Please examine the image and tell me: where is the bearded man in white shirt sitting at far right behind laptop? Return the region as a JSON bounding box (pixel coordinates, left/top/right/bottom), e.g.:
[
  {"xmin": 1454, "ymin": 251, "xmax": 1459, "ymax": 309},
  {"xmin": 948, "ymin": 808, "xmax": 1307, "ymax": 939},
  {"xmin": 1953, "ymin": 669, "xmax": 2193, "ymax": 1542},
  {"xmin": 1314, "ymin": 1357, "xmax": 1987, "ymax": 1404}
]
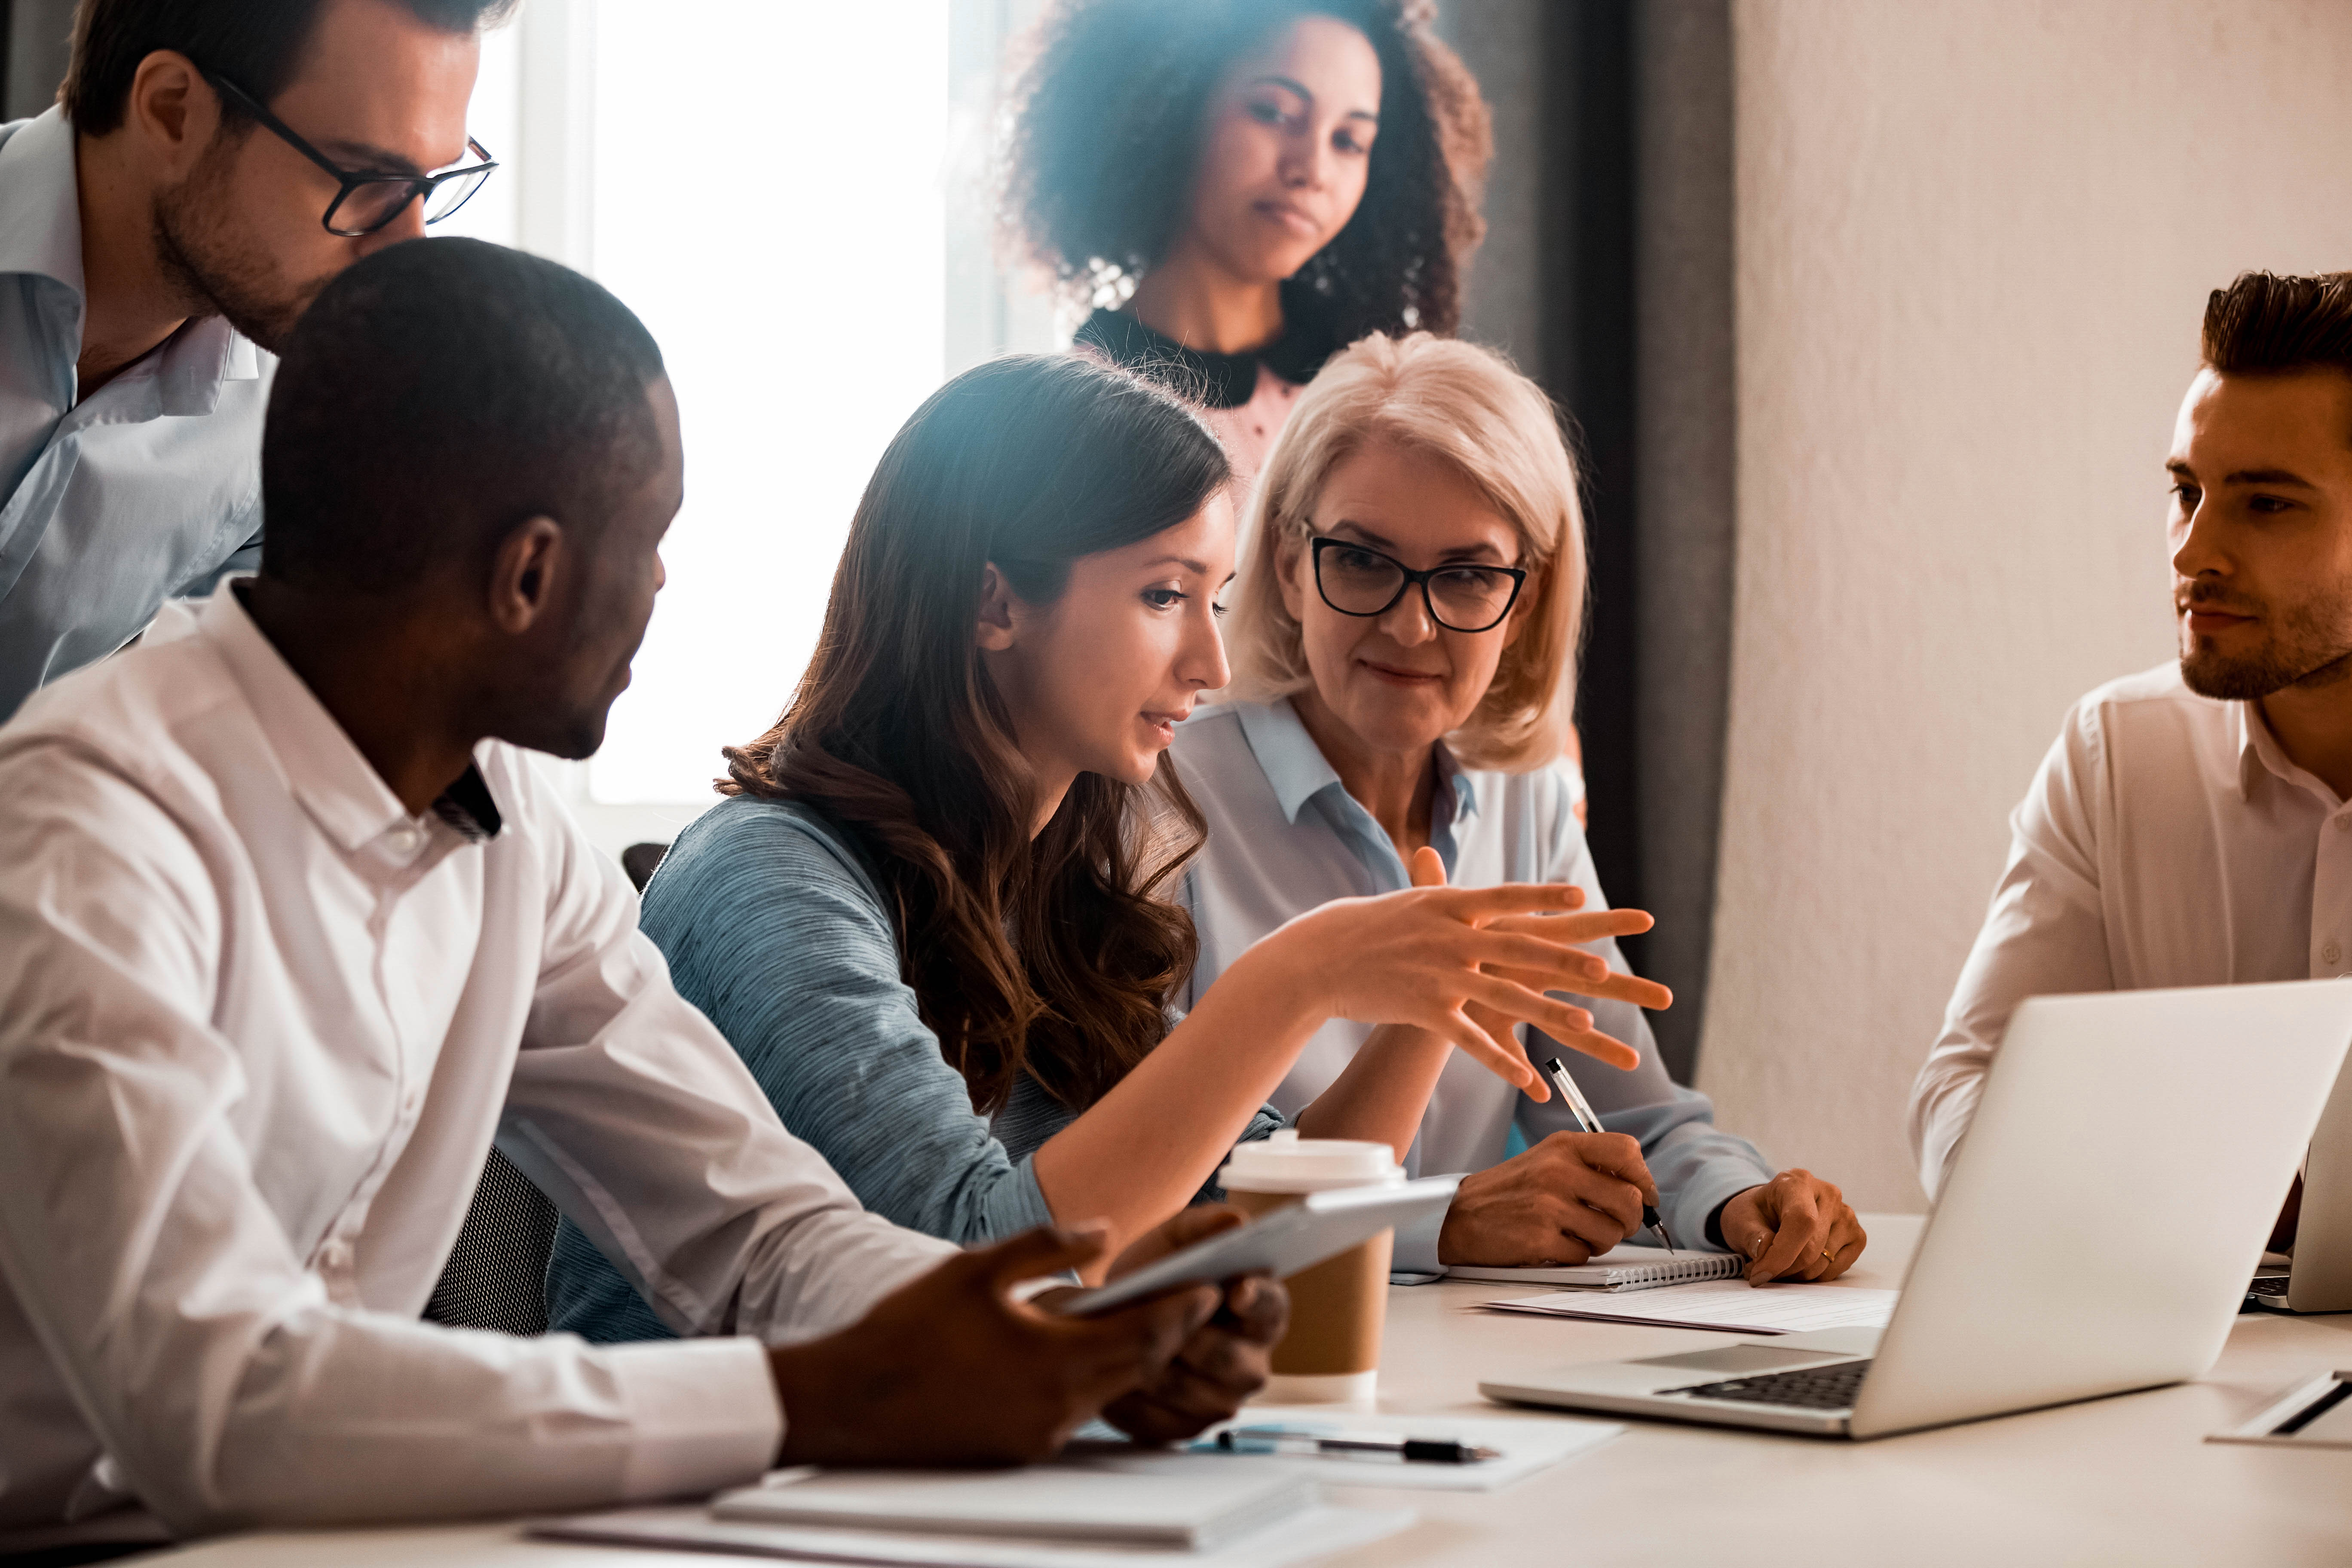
[{"xmin": 1910, "ymin": 273, "xmax": 2352, "ymax": 1246}]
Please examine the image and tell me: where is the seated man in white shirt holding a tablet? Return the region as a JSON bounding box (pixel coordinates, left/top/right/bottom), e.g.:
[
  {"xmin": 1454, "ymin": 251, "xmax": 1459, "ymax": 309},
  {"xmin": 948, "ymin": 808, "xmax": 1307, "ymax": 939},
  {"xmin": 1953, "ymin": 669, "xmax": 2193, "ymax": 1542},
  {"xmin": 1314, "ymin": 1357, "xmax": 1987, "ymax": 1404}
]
[{"xmin": 0, "ymin": 240, "xmax": 1284, "ymax": 1544}]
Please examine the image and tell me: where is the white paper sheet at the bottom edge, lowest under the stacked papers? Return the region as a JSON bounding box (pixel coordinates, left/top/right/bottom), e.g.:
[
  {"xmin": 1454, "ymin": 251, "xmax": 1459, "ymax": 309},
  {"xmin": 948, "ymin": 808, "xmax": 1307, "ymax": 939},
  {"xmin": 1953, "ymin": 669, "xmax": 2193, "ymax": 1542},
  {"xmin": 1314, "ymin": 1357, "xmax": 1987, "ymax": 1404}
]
[{"xmin": 529, "ymin": 1504, "xmax": 1414, "ymax": 1568}]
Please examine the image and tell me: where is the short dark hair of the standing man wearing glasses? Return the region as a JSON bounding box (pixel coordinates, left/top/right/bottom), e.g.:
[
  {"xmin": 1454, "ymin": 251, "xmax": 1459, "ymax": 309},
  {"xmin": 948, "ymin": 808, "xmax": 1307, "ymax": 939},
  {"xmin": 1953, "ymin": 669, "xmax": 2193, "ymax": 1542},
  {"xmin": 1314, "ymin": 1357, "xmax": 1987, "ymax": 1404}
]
[{"xmin": 56, "ymin": 0, "xmax": 518, "ymax": 136}]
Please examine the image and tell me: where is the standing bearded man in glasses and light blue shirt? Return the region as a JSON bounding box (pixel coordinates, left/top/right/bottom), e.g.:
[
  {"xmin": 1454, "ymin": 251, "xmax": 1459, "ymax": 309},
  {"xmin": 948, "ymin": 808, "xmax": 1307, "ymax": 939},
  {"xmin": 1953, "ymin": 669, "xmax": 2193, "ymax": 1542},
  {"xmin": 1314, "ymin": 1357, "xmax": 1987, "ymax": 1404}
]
[{"xmin": 0, "ymin": 0, "xmax": 513, "ymax": 720}]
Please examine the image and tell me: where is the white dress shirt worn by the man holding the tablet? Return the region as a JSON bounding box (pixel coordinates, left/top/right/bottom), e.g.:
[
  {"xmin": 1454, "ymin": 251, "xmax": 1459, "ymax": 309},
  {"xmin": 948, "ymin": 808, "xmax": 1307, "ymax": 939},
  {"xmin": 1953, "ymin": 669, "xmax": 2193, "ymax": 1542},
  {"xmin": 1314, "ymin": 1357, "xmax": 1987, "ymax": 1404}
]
[{"xmin": 0, "ymin": 585, "xmax": 952, "ymax": 1530}]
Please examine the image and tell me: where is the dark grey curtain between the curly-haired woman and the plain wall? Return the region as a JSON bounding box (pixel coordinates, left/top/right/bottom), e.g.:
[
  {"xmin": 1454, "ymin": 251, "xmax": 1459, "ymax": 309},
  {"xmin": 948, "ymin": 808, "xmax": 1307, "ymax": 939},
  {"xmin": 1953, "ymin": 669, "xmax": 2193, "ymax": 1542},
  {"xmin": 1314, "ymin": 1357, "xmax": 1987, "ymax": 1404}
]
[{"xmin": 1442, "ymin": 0, "xmax": 1736, "ymax": 1081}]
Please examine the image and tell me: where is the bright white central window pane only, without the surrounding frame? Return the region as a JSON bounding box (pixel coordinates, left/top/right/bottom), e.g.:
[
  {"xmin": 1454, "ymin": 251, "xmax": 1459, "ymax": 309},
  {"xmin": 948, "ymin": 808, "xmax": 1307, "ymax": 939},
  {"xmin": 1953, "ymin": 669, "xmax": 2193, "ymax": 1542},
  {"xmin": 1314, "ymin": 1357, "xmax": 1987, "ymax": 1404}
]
[{"xmin": 588, "ymin": 0, "xmax": 948, "ymax": 802}]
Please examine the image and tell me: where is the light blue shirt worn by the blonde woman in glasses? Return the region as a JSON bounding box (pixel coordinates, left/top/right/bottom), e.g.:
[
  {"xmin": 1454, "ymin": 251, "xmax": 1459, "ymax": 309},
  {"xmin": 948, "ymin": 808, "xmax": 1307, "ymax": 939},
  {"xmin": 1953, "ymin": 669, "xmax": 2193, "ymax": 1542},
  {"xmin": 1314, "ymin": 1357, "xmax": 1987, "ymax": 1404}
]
[{"xmin": 1169, "ymin": 701, "xmax": 1771, "ymax": 1272}]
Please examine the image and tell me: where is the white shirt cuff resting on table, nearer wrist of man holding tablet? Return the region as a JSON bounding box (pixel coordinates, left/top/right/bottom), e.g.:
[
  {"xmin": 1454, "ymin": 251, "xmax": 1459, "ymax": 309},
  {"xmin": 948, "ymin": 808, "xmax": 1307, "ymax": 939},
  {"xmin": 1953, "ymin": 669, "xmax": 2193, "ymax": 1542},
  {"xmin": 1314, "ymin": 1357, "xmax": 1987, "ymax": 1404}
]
[{"xmin": 616, "ymin": 1338, "xmax": 783, "ymax": 1502}]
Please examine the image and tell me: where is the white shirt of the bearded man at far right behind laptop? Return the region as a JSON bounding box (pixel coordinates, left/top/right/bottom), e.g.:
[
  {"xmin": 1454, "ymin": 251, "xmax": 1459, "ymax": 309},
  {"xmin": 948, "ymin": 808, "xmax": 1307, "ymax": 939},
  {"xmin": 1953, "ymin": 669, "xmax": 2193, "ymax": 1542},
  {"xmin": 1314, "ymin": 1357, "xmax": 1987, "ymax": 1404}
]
[{"xmin": 1910, "ymin": 665, "xmax": 2352, "ymax": 1197}]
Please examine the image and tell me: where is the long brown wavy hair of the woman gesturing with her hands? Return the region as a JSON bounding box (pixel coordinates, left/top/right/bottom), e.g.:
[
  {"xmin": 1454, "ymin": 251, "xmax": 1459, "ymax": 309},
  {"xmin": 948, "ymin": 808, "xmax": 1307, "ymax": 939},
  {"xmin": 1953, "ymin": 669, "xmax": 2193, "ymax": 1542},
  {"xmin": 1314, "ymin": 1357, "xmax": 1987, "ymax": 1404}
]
[{"xmin": 720, "ymin": 355, "xmax": 1230, "ymax": 1112}]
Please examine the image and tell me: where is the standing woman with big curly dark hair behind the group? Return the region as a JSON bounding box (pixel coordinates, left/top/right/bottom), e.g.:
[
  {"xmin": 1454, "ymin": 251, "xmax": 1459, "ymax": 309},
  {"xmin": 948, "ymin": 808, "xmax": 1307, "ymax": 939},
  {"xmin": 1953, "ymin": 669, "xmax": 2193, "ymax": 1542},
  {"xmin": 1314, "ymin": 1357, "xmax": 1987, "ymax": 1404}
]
[{"xmin": 1004, "ymin": 0, "xmax": 1489, "ymax": 498}]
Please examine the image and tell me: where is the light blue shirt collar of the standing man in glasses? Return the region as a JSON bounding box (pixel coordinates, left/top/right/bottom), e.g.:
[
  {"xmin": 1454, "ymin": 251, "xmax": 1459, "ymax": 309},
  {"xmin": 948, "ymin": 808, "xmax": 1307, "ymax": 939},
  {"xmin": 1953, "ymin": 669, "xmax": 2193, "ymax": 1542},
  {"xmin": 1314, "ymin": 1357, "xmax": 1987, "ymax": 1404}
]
[{"xmin": 0, "ymin": 106, "xmax": 261, "ymax": 419}]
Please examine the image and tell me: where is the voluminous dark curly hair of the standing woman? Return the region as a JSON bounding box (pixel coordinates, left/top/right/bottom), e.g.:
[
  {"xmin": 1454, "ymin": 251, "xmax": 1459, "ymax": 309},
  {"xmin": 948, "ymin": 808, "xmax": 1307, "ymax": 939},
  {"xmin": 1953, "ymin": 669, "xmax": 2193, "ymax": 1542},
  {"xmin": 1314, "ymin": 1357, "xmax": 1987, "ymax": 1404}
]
[{"xmin": 1002, "ymin": 0, "xmax": 1494, "ymax": 343}]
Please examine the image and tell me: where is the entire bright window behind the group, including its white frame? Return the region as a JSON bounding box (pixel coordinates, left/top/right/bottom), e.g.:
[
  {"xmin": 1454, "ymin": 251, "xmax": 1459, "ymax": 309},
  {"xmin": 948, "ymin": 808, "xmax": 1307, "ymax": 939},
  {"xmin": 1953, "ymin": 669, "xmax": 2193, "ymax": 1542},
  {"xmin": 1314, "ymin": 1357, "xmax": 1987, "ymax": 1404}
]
[{"xmin": 435, "ymin": 0, "xmax": 1054, "ymax": 846}]
